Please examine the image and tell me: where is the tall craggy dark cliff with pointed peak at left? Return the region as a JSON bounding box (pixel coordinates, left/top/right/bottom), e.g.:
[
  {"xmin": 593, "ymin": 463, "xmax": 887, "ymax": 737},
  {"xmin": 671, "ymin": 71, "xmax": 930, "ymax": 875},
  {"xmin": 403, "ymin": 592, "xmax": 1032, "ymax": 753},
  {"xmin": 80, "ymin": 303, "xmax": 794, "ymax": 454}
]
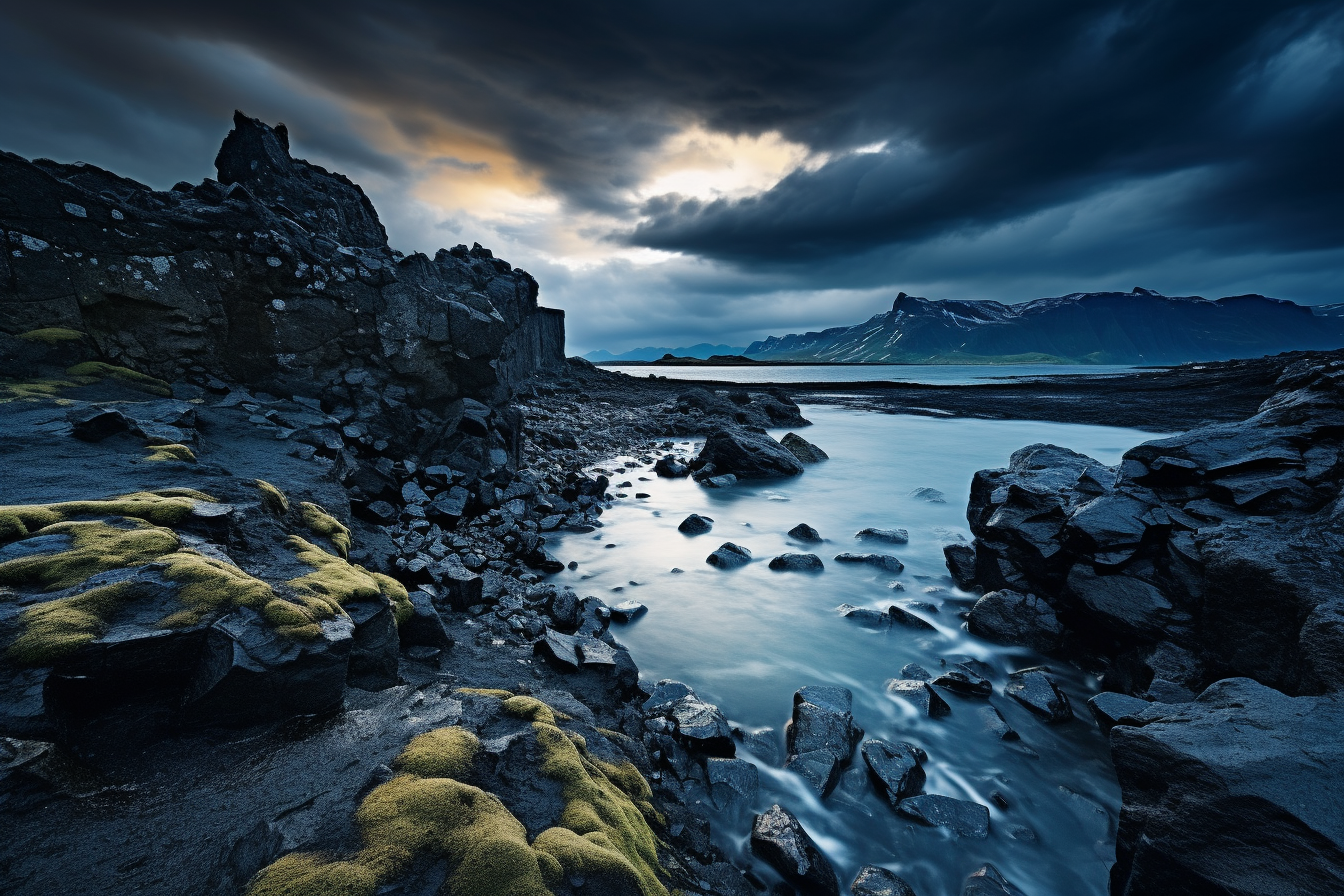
[{"xmin": 0, "ymin": 113, "xmax": 564, "ymax": 459}]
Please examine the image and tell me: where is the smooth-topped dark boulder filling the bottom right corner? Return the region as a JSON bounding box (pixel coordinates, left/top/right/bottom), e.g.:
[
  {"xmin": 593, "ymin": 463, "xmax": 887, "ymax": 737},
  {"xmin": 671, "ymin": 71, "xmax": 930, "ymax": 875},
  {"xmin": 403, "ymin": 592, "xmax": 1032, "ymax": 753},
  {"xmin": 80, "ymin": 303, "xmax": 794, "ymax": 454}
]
[{"xmin": 1110, "ymin": 678, "xmax": 1344, "ymax": 896}]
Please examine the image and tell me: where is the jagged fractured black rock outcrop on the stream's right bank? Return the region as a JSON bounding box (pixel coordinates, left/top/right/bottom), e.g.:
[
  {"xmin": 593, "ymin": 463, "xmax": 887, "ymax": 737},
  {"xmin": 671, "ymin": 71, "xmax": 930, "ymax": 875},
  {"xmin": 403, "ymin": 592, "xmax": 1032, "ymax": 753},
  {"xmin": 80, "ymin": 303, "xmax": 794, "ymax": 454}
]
[{"xmin": 966, "ymin": 355, "xmax": 1344, "ymax": 700}]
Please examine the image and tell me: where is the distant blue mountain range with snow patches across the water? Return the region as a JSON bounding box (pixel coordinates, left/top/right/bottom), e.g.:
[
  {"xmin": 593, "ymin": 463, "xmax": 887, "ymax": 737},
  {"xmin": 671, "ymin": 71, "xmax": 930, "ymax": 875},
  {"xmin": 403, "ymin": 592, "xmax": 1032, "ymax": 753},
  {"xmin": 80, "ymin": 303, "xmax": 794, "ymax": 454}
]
[{"xmin": 743, "ymin": 287, "xmax": 1344, "ymax": 364}]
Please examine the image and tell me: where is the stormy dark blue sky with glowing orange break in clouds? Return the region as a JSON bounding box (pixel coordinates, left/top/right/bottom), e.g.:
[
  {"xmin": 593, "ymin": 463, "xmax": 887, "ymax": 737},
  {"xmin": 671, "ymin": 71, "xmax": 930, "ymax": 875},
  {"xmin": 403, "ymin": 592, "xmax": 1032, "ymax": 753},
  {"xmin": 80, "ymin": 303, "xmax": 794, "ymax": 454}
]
[{"xmin": 0, "ymin": 0, "xmax": 1344, "ymax": 353}]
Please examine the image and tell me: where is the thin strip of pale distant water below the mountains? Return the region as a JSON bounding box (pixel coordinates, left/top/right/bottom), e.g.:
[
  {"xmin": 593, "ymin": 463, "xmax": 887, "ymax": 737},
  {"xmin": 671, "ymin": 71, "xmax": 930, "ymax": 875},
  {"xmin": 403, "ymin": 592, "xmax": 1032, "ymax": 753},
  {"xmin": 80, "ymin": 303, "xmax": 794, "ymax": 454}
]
[{"xmin": 603, "ymin": 364, "xmax": 1138, "ymax": 386}]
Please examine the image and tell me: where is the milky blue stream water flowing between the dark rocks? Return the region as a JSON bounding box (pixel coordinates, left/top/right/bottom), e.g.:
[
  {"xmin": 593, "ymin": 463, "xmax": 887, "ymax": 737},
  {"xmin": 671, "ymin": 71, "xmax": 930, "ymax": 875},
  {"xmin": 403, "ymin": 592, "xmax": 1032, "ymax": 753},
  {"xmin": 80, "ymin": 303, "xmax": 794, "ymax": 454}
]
[{"xmin": 548, "ymin": 406, "xmax": 1157, "ymax": 896}]
